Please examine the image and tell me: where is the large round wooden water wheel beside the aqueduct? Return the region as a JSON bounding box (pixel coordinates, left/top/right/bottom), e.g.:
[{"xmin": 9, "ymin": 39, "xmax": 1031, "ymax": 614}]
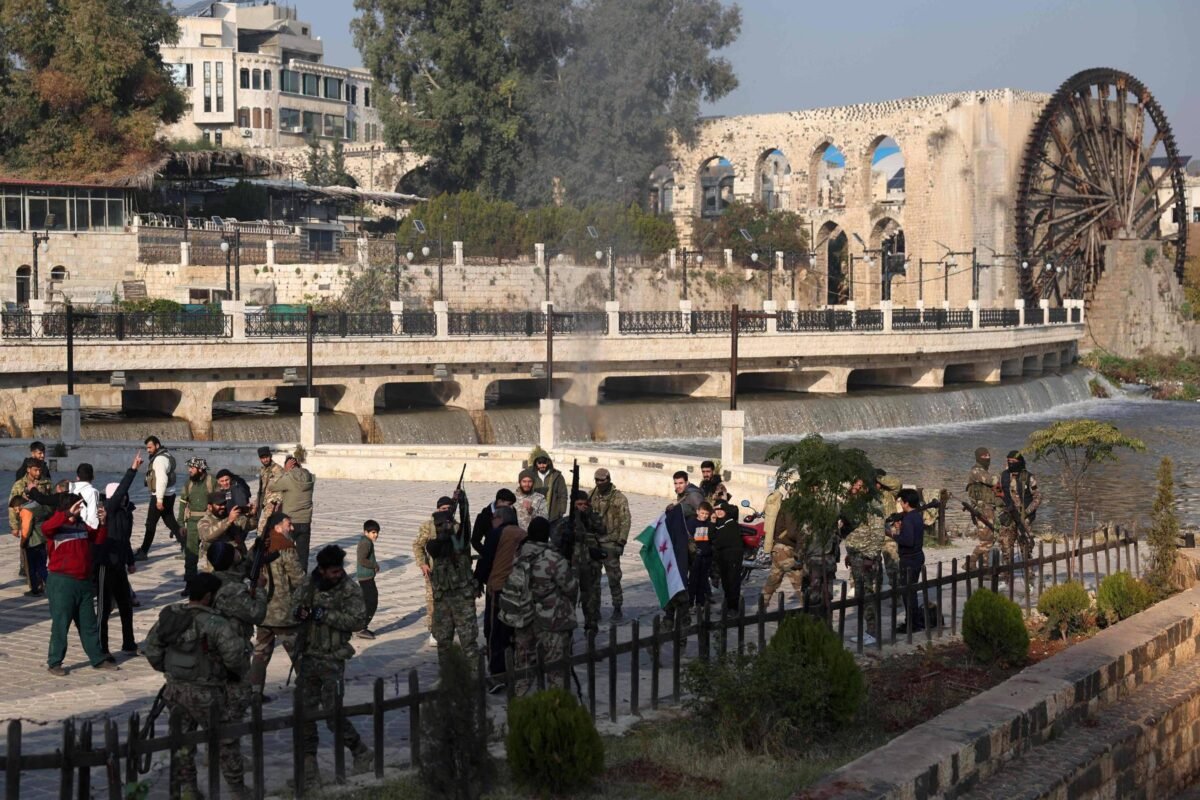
[{"xmin": 1016, "ymin": 68, "xmax": 1187, "ymax": 302}]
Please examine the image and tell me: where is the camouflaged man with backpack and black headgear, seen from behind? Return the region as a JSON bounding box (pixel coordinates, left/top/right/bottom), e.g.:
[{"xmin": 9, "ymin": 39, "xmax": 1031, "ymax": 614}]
[{"xmin": 509, "ymin": 517, "xmax": 580, "ymax": 693}]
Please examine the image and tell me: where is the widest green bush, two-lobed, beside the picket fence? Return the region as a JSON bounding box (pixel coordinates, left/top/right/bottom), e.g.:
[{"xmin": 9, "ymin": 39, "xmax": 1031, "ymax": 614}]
[{"xmin": 684, "ymin": 614, "xmax": 866, "ymax": 753}]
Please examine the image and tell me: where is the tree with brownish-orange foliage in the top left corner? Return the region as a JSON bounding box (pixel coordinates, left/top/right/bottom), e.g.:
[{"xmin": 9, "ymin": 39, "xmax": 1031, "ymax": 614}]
[{"xmin": 0, "ymin": 0, "xmax": 184, "ymax": 179}]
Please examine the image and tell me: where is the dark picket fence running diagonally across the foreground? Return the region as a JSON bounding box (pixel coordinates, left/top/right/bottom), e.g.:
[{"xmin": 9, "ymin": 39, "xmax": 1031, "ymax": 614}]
[{"xmin": 0, "ymin": 527, "xmax": 1140, "ymax": 800}]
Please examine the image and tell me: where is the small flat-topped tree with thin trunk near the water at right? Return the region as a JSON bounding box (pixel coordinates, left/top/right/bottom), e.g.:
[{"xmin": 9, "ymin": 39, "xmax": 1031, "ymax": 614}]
[{"xmin": 1026, "ymin": 420, "xmax": 1146, "ymax": 579}]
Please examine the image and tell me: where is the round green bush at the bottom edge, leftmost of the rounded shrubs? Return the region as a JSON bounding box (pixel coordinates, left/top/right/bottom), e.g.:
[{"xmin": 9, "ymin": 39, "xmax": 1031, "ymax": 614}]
[{"xmin": 504, "ymin": 688, "xmax": 604, "ymax": 795}]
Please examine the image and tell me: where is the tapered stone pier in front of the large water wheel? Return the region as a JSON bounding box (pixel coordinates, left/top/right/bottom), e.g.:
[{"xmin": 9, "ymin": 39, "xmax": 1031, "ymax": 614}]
[{"xmin": 1080, "ymin": 240, "xmax": 1200, "ymax": 357}]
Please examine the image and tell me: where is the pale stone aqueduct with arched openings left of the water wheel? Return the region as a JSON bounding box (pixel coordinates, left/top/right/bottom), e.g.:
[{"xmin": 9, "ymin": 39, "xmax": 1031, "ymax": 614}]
[{"xmin": 655, "ymin": 89, "xmax": 1050, "ymax": 307}]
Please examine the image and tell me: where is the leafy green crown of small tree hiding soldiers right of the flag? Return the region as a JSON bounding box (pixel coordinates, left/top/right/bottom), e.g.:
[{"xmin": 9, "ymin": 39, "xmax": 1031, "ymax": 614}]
[{"xmin": 767, "ymin": 434, "xmax": 878, "ymax": 556}]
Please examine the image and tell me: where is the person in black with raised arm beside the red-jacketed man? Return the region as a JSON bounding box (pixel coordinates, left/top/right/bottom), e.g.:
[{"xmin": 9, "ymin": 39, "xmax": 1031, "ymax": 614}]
[{"xmin": 95, "ymin": 452, "xmax": 142, "ymax": 655}]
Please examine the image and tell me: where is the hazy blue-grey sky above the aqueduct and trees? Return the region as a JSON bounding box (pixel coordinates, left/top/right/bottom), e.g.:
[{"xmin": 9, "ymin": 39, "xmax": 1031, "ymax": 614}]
[{"xmin": 278, "ymin": 0, "xmax": 1200, "ymax": 158}]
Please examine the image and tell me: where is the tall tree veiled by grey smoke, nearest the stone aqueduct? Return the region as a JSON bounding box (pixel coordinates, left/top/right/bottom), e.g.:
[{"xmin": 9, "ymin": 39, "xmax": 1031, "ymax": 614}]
[{"xmin": 518, "ymin": 0, "xmax": 742, "ymax": 204}]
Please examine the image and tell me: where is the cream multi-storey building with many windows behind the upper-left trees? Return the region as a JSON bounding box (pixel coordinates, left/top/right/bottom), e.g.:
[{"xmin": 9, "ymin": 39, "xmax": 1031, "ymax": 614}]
[{"xmin": 162, "ymin": 0, "xmax": 383, "ymax": 148}]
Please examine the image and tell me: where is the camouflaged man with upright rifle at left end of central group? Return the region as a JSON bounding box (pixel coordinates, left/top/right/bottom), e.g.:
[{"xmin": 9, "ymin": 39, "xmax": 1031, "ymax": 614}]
[{"xmin": 425, "ymin": 489, "xmax": 479, "ymax": 669}]
